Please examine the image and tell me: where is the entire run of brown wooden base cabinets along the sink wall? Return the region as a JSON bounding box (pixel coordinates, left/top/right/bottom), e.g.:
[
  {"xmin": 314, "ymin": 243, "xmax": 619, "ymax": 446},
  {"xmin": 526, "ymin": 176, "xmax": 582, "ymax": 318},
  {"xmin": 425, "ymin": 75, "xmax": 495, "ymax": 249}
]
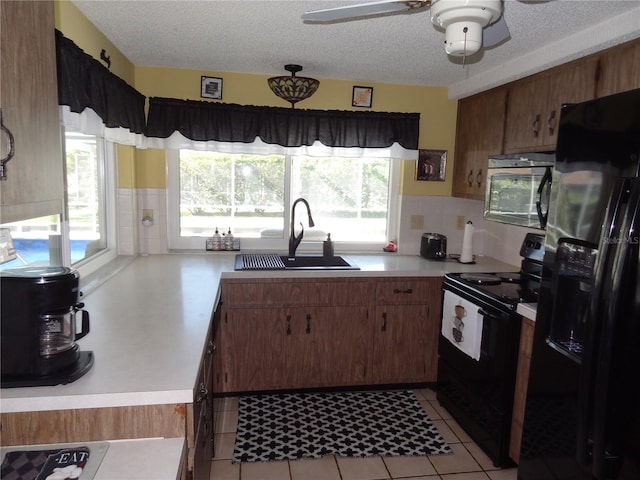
[{"xmin": 216, "ymin": 278, "xmax": 442, "ymax": 393}]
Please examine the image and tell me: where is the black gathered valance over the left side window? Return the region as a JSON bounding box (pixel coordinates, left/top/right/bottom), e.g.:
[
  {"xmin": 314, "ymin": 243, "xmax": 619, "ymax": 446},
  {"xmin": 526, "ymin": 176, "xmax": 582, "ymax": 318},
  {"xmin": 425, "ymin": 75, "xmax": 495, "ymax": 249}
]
[{"xmin": 56, "ymin": 30, "xmax": 146, "ymax": 134}]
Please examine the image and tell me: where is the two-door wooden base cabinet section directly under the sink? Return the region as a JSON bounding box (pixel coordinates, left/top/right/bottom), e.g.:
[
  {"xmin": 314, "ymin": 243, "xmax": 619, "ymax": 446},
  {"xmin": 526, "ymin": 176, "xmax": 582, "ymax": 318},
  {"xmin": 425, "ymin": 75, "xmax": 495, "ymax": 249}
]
[{"xmin": 221, "ymin": 279, "xmax": 371, "ymax": 392}]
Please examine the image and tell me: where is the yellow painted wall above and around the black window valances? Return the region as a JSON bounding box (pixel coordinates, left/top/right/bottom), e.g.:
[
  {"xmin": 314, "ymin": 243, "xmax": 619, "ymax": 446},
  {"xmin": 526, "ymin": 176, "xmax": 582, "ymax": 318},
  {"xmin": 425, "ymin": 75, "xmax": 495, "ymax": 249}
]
[{"xmin": 55, "ymin": 0, "xmax": 457, "ymax": 195}]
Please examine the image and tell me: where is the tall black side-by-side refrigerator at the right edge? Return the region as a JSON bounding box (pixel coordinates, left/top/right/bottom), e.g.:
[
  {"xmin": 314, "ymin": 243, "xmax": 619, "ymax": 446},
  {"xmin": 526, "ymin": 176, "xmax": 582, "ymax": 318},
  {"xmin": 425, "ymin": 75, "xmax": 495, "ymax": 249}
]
[{"xmin": 518, "ymin": 89, "xmax": 640, "ymax": 480}]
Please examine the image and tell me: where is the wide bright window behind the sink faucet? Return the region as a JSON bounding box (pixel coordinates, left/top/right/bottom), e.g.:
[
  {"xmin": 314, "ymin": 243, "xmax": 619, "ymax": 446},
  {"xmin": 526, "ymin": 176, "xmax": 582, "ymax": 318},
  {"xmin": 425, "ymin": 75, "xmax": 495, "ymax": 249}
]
[{"xmin": 168, "ymin": 150, "xmax": 400, "ymax": 251}]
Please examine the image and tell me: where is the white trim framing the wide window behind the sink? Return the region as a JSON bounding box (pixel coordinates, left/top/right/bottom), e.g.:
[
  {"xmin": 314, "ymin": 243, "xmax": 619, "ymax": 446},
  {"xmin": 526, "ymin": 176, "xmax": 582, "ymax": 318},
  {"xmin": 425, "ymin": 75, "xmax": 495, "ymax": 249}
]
[{"xmin": 166, "ymin": 150, "xmax": 402, "ymax": 253}]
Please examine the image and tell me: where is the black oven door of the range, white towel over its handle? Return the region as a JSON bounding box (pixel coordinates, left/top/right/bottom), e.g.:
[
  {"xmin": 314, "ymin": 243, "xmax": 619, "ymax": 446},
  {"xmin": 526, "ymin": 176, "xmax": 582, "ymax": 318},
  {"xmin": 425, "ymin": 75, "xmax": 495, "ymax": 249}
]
[{"xmin": 437, "ymin": 283, "xmax": 521, "ymax": 467}]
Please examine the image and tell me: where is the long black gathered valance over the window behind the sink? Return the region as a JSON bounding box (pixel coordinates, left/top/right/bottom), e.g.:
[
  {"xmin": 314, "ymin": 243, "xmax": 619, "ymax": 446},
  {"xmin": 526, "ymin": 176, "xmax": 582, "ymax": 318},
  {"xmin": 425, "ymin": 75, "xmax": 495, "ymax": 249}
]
[{"xmin": 146, "ymin": 97, "xmax": 420, "ymax": 150}]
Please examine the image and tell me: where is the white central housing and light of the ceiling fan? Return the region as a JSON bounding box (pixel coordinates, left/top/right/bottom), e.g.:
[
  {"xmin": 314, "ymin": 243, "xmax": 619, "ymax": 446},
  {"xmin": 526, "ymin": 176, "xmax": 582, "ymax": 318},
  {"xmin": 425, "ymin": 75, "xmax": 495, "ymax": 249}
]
[{"xmin": 431, "ymin": 0, "xmax": 502, "ymax": 56}]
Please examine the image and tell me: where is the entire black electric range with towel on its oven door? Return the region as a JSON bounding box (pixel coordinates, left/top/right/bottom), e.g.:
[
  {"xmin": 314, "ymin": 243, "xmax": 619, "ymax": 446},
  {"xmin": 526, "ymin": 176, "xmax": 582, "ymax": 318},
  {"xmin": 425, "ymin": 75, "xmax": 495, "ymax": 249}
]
[{"xmin": 437, "ymin": 234, "xmax": 544, "ymax": 468}]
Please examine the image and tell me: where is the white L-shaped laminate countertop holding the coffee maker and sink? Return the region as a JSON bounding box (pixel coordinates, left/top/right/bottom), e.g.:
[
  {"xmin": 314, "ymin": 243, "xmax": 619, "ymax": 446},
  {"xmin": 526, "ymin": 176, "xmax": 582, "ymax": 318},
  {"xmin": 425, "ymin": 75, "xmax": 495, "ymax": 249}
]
[{"xmin": 0, "ymin": 252, "xmax": 519, "ymax": 413}]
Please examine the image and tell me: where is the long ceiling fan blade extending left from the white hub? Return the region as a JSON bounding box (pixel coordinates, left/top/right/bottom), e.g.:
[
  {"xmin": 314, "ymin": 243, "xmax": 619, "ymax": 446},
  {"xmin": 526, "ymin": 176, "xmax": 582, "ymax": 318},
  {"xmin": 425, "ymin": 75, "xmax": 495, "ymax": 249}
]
[{"xmin": 302, "ymin": 0, "xmax": 431, "ymax": 23}]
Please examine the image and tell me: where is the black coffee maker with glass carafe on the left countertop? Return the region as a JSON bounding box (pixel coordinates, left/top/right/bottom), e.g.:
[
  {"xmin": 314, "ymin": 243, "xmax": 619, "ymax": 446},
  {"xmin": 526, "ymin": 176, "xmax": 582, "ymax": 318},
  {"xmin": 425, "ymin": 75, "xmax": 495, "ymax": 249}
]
[{"xmin": 0, "ymin": 267, "xmax": 93, "ymax": 388}]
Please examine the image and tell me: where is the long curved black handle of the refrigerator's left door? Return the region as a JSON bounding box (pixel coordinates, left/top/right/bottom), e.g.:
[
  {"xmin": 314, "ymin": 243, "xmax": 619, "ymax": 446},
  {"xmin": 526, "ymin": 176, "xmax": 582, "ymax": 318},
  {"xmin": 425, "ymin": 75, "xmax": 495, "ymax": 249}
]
[{"xmin": 576, "ymin": 181, "xmax": 625, "ymax": 467}]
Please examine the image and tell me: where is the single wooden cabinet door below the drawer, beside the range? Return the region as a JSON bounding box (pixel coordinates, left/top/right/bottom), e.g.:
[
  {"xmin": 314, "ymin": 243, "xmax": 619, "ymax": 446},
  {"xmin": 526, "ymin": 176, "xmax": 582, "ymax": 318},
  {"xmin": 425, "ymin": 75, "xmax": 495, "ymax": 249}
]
[{"xmin": 373, "ymin": 305, "xmax": 435, "ymax": 383}]
